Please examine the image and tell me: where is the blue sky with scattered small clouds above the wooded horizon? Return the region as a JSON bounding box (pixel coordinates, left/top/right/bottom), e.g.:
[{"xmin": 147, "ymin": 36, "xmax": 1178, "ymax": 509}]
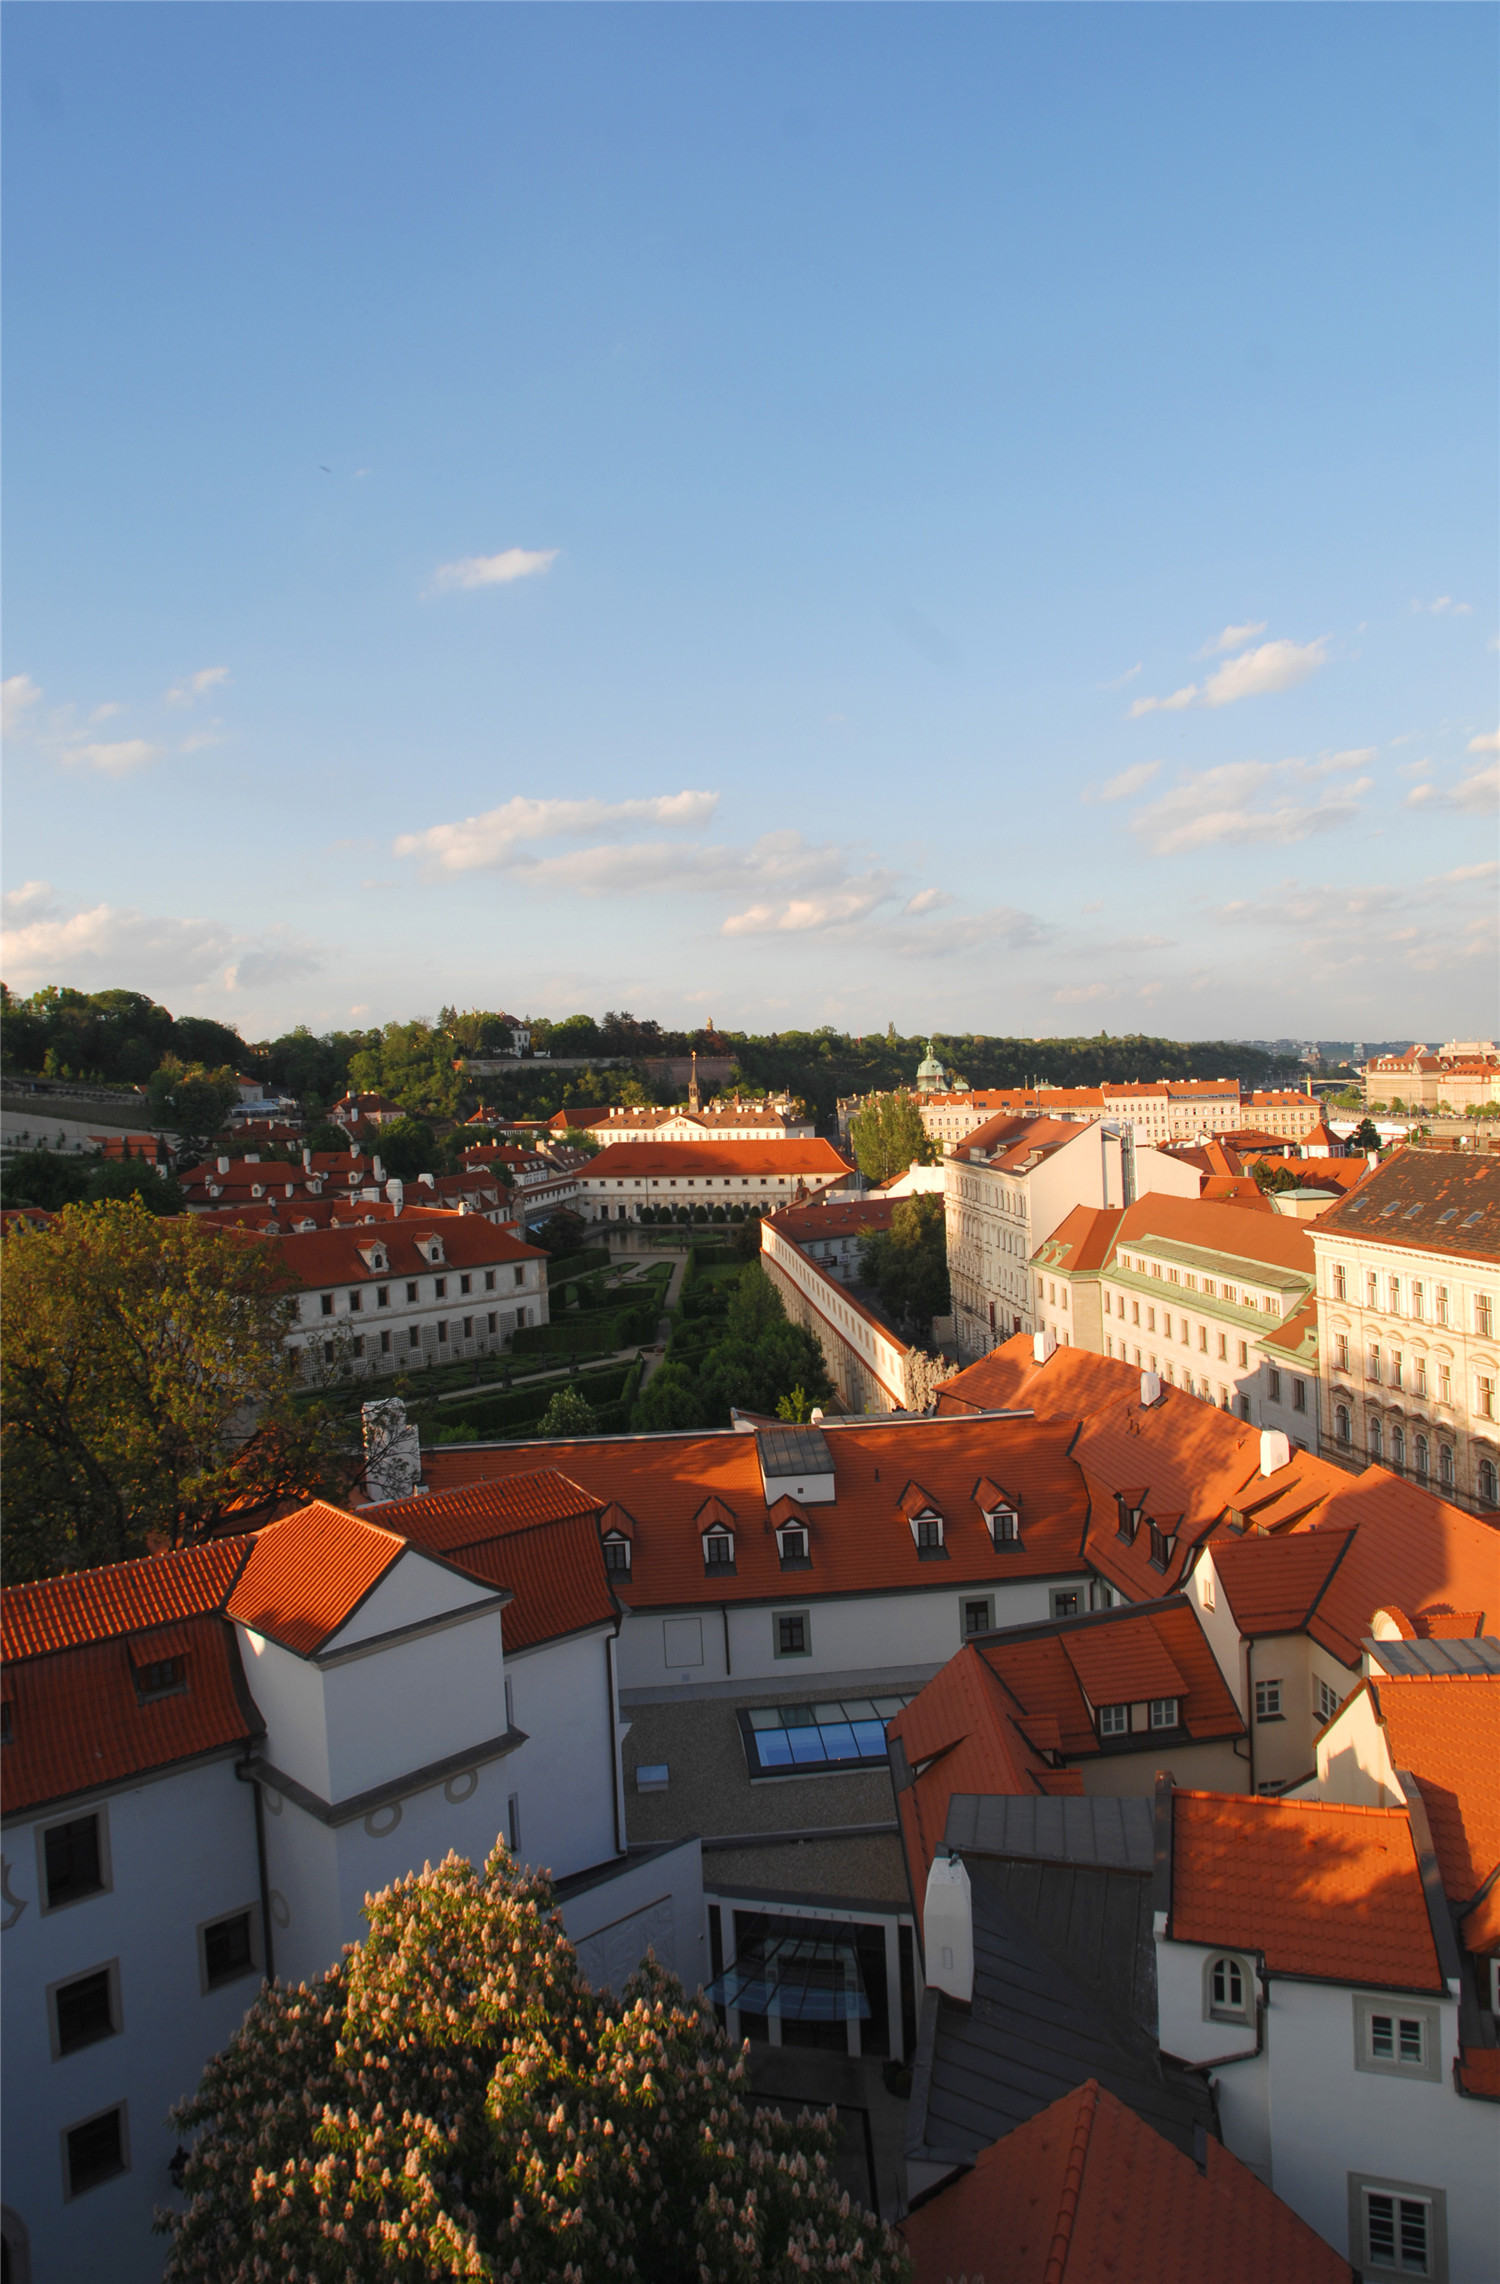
[{"xmin": 5, "ymin": 0, "xmax": 1500, "ymax": 1039}]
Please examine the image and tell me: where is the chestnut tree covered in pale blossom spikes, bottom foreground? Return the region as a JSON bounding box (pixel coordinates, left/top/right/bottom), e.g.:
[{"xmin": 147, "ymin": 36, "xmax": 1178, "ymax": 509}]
[{"xmin": 160, "ymin": 1845, "xmax": 906, "ymax": 2284}]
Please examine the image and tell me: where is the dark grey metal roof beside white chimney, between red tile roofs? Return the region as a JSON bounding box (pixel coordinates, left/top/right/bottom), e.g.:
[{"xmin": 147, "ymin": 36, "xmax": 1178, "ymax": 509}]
[{"xmin": 906, "ymin": 1857, "xmax": 1212, "ymax": 2165}]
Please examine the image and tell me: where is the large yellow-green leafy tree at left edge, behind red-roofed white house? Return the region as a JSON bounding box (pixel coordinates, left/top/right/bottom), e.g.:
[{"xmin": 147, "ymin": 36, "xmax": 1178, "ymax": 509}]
[{"xmin": 0, "ymin": 1176, "xmax": 356, "ymax": 1578}]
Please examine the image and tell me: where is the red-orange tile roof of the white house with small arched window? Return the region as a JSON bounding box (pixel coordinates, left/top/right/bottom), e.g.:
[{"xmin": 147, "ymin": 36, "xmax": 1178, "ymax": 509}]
[{"xmin": 1171, "ymin": 1793, "xmax": 1445, "ymax": 1992}]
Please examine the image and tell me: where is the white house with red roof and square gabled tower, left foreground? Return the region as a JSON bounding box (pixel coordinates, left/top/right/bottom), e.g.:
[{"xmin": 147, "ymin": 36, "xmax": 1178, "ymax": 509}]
[{"xmin": 2, "ymin": 1471, "xmax": 708, "ymax": 2284}]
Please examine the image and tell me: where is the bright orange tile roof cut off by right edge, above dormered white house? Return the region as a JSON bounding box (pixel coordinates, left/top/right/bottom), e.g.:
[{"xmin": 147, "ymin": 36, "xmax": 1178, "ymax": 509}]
[{"xmin": 1365, "ymin": 1674, "xmax": 1500, "ymax": 1951}]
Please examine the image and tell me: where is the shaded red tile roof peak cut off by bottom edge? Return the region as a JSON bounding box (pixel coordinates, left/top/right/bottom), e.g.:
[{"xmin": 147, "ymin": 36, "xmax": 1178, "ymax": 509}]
[{"xmin": 902, "ymin": 2078, "xmax": 1354, "ymax": 2284}]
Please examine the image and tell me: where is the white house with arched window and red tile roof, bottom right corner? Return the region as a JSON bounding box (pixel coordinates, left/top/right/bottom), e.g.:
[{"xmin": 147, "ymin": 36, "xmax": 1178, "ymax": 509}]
[{"xmin": 1155, "ymin": 1779, "xmax": 1500, "ymax": 2284}]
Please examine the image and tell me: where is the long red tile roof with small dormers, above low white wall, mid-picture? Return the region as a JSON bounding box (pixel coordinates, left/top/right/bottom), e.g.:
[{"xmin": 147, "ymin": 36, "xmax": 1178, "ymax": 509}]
[{"xmin": 408, "ymin": 1418, "xmax": 1087, "ymax": 1610}]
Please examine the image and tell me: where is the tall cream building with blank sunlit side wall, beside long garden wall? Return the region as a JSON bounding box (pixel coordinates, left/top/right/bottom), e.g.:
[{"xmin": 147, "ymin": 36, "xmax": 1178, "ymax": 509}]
[{"xmin": 943, "ymin": 1115, "xmax": 1199, "ymax": 1361}]
